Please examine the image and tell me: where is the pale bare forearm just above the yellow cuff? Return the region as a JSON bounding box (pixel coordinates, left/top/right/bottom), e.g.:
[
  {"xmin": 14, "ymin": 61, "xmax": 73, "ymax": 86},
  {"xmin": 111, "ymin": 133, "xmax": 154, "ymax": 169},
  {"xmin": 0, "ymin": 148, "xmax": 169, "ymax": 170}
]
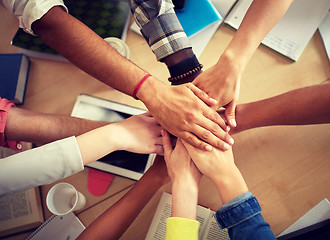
[{"xmin": 172, "ymin": 176, "xmax": 198, "ymax": 220}]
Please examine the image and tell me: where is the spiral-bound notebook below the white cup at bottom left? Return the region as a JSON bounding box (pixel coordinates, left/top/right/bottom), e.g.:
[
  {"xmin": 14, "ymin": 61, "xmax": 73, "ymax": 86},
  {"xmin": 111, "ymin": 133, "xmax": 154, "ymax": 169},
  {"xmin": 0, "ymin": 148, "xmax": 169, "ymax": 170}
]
[{"xmin": 25, "ymin": 212, "xmax": 85, "ymax": 240}]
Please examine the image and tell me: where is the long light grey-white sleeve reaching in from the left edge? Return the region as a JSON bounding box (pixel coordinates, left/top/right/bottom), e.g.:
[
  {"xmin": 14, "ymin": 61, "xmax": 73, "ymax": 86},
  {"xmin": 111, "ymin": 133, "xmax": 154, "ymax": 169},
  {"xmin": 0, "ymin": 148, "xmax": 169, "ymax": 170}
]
[{"xmin": 0, "ymin": 136, "xmax": 84, "ymax": 196}]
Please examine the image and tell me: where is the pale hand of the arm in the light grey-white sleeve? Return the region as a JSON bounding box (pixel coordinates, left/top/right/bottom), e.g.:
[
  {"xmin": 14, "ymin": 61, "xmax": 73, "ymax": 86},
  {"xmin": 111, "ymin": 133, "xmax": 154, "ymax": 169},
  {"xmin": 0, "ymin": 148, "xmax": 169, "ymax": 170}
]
[{"xmin": 114, "ymin": 113, "xmax": 164, "ymax": 155}]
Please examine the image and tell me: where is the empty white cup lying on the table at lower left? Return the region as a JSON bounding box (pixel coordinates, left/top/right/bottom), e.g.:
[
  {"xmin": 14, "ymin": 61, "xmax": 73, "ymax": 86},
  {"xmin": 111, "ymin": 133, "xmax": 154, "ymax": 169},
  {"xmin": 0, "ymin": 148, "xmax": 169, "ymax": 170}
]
[{"xmin": 46, "ymin": 182, "xmax": 86, "ymax": 215}]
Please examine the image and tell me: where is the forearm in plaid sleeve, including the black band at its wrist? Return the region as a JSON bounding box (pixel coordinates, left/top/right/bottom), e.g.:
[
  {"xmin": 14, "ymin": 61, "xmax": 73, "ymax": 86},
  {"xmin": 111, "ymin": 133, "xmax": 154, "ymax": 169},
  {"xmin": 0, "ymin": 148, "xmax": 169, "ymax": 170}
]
[{"xmin": 129, "ymin": 0, "xmax": 200, "ymax": 85}]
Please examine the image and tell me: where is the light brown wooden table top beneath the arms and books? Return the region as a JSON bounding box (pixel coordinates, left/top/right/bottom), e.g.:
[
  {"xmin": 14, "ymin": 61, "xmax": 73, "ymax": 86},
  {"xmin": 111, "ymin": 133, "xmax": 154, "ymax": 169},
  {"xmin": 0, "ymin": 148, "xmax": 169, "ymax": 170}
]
[{"xmin": 0, "ymin": 4, "xmax": 330, "ymax": 239}]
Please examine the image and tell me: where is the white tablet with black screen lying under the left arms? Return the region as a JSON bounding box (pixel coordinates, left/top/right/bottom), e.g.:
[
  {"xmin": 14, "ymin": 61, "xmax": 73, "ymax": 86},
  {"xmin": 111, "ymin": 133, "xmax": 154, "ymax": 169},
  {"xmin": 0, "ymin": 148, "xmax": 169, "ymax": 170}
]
[{"xmin": 71, "ymin": 94, "xmax": 156, "ymax": 180}]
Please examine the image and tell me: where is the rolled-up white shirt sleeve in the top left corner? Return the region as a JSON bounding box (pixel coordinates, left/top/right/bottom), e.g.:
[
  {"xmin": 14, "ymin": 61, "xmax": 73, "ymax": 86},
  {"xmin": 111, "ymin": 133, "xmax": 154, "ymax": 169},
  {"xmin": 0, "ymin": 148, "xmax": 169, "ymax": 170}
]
[{"xmin": 0, "ymin": 0, "xmax": 68, "ymax": 35}]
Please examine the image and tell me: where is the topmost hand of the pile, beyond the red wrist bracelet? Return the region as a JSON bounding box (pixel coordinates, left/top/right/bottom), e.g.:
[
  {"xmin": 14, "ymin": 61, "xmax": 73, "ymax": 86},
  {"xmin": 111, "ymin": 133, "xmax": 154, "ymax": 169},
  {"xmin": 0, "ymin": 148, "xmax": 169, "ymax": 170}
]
[{"xmin": 144, "ymin": 83, "xmax": 233, "ymax": 151}]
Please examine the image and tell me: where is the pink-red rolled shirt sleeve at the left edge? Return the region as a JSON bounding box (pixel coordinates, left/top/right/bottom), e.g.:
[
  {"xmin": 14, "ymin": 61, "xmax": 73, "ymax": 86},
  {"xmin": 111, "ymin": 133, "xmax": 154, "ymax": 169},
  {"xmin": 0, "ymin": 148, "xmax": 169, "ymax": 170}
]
[{"xmin": 0, "ymin": 97, "xmax": 22, "ymax": 151}]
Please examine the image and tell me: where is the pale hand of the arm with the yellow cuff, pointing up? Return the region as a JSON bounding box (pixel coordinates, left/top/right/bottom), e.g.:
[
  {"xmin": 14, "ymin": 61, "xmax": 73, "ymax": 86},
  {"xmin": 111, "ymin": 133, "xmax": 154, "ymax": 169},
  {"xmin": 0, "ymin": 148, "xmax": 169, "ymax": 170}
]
[{"xmin": 161, "ymin": 129, "xmax": 203, "ymax": 184}]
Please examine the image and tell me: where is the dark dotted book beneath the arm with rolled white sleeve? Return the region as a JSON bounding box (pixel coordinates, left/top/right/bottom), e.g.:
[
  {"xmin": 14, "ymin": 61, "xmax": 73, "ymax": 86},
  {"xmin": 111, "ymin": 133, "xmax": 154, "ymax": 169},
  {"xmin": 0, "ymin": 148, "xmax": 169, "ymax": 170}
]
[{"xmin": 12, "ymin": 0, "xmax": 130, "ymax": 61}]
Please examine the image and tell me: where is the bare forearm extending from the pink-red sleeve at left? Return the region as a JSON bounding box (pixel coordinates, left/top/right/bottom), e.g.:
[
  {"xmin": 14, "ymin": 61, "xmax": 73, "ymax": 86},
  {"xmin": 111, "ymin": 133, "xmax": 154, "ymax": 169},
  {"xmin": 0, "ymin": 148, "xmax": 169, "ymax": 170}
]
[{"xmin": 5, "ymin": 107, "xmax": 107, "ymax": 144}]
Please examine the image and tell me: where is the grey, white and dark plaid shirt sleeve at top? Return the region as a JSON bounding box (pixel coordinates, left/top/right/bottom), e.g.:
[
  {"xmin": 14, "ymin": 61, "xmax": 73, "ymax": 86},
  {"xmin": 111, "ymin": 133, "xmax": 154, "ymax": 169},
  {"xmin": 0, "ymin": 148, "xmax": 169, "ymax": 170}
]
[{"xmin": 129, "ymin": 0, "xmax": 191, "ymax": 61}]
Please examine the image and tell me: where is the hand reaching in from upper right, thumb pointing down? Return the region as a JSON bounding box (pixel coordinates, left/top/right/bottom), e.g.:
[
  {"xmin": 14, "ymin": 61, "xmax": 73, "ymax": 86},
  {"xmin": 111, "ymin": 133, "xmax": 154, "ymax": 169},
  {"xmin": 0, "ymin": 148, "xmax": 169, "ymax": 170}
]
[{"xmin": 193, "ymin": 57, "xmax": 241, "ymax": 127}]
